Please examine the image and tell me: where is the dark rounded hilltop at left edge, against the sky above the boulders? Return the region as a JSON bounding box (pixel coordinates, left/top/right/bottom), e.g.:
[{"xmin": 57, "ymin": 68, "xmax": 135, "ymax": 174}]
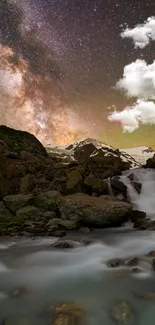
[{"xmin": 0, "ymin": 125, "xmax": 47, "ymax": 156}]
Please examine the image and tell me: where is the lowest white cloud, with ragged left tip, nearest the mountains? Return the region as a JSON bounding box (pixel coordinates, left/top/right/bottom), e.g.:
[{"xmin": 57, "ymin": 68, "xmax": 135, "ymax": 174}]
[{"xmin": 108, "ymin": 99, "xmax": 155, "ymax": 132}]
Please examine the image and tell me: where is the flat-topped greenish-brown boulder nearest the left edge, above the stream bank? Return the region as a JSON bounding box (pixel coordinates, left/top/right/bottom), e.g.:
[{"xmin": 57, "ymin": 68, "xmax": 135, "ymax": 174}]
[{"xmin": 3, "ymin": 194, "xmax": 34, "ymax": 213}]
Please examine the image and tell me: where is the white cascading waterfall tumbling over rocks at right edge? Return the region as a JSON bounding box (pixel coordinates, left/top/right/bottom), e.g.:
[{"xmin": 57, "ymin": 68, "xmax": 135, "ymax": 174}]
[{"xmin": 120, "ymin": 168, "xmax": 155, "ymax": 219}]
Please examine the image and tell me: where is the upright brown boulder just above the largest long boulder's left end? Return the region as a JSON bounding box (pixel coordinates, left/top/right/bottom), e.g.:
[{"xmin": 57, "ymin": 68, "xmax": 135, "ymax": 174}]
[{"xmin": 66, "ymin": 169, "xmax": 83, "ymax": 194}]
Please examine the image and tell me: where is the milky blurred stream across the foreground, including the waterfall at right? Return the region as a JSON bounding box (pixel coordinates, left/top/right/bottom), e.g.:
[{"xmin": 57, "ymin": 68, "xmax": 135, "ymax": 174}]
[{"xmin": 0, "ymin": 169, "xmax": 155, "ymax": 325}]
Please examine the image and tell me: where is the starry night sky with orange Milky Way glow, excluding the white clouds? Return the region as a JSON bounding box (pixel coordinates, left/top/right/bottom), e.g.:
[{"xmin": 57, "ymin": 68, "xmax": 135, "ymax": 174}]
[{"xmin": 0, "ymin": 0, "xmax": 155, "ymax": 148}]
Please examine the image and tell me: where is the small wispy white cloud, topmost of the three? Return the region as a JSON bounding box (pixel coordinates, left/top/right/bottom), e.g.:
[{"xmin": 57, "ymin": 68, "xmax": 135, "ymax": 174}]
[{"xmin": 121, "ymin": 17, "xmax": 155, "ymax": 49}]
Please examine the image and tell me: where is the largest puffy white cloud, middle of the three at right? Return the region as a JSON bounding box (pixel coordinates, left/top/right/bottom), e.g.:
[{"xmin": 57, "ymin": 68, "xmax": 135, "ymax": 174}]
[{"xmin": 116, "ymin": 59, "xmax": 155, "ymax": 99}]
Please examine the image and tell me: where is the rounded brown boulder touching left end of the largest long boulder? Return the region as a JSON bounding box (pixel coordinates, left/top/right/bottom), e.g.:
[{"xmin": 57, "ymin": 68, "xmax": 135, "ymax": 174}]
[{"xmin": 34, "ymin": 191, "xmax": 60, "ymax": 212}]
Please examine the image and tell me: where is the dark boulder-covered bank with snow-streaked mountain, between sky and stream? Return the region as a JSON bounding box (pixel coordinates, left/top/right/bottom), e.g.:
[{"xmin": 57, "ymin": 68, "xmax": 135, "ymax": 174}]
[{"xmin": 0, "ymin": 126, "xmax": 155, "ymax": 237}]
